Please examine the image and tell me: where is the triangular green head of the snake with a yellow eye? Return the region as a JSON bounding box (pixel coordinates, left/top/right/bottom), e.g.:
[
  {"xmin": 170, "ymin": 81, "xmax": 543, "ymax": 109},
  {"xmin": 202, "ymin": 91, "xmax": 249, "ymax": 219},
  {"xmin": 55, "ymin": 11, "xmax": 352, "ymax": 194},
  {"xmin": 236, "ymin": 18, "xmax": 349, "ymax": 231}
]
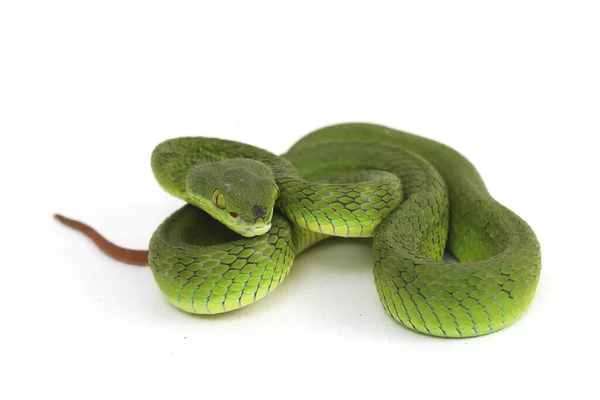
[{"xmin": 186, "ymin": 158, "xmax": 279, "ymax": 237}]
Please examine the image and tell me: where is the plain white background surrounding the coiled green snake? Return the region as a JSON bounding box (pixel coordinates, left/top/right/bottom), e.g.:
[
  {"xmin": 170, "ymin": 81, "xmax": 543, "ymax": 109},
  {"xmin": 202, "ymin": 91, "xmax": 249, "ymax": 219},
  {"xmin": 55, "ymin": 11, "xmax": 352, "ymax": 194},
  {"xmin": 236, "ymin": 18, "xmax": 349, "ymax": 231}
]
[{"xmin": 0, "ymin": 0, "xmax": 600, "ymax": 399}]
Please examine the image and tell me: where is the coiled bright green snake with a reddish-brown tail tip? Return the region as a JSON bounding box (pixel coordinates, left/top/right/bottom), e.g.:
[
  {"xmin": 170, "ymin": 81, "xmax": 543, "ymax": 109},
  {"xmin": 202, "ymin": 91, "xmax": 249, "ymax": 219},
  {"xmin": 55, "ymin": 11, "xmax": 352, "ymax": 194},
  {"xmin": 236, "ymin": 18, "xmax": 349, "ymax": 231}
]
[{"xmin": 58, "ymin": 123, "xmax": 541, "ymax": 337}]
